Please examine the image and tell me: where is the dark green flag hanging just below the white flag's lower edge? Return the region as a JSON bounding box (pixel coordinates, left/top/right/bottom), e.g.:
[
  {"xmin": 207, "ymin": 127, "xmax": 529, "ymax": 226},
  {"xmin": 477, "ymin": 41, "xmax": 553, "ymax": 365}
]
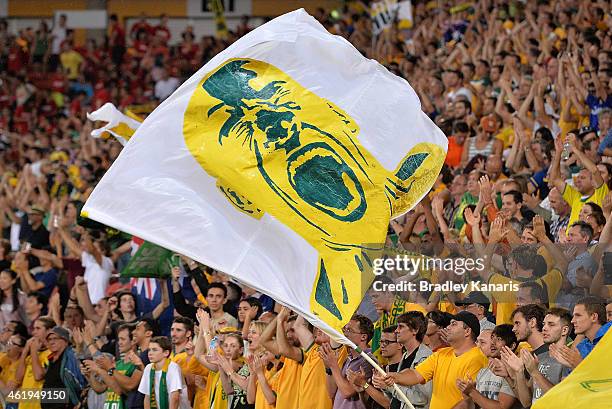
[{"xmin": 121, "ymin": 241, "xmax": 179, "ymax": 278}]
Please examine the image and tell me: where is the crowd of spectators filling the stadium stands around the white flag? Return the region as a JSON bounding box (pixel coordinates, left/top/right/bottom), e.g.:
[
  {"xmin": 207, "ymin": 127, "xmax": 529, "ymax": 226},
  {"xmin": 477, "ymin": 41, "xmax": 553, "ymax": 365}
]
[{"xmin": 0, "ymin": 0, "xmax": 612, "ymax": 409}]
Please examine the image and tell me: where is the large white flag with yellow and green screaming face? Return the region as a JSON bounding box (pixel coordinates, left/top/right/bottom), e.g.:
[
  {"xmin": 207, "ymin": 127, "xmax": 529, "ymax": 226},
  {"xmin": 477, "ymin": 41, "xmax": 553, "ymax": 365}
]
[{"xmin": 84, "ymin": 10, "xmax": 446, "ymax": 338}]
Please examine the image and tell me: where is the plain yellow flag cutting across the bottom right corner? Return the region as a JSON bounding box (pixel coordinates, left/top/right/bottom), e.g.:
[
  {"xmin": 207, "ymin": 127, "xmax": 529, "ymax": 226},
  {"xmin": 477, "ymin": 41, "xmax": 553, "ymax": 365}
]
[{"xmin": 533, "ymin": 331, "xmax": 612, "ymax": 409}]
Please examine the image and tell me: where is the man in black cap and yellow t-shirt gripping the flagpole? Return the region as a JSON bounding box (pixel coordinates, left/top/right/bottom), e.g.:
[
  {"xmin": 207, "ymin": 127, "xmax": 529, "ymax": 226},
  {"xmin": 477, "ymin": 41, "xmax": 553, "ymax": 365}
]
[{"xmin": 385, "ymin": 311, "xmax": 487, "ymax": 409}]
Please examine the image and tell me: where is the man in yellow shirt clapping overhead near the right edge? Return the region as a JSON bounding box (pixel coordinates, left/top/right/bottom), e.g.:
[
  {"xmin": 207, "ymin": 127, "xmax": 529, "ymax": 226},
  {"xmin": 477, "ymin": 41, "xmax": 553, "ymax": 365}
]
[{"xmin": 548, "ymin": 132, "xmax": 609, "ymax": 230}]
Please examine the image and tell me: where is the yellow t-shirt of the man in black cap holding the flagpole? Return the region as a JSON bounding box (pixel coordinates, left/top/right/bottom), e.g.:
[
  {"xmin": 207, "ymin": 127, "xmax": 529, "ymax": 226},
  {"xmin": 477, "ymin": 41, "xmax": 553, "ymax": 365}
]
[{"xmin": 415, "ymin": 347, "xmax": 487, "ymax": 409}]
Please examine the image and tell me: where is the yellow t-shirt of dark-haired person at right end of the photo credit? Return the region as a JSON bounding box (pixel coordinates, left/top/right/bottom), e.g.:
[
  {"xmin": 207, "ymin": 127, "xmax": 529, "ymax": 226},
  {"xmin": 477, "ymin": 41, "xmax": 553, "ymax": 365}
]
[{"xmin": 489, "ymin": 268, "xmax": 563, "ymax": 325}]
